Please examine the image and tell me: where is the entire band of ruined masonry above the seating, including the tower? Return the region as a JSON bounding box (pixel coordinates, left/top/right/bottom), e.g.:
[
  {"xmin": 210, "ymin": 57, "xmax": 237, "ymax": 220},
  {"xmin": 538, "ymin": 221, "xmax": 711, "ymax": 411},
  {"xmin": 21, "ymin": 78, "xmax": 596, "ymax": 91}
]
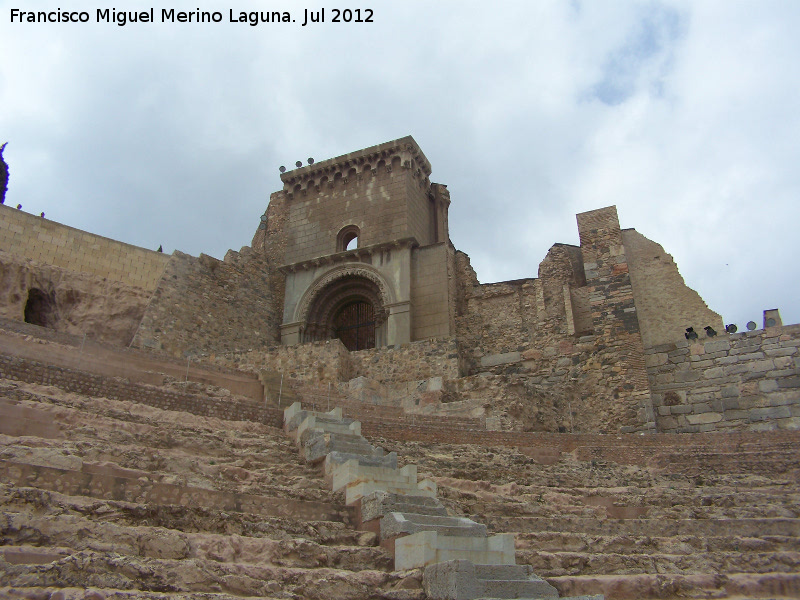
[{"xmin": 0, "ymin": 137, "xmax": 800, "ymax": 433}]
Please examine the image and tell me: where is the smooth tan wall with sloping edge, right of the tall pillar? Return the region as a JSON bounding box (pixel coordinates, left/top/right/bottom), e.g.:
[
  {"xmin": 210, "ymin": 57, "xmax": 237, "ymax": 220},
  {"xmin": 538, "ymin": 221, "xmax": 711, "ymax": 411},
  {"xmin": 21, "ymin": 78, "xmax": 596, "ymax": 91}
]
[{"xmin": 622, "ymin": 229, "xmax": 724, "ymax": 348}]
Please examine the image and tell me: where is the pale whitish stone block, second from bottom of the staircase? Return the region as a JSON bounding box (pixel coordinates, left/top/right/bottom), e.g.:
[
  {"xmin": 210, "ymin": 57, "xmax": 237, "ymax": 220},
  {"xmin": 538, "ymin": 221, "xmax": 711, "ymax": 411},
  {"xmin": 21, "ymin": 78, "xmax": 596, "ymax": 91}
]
[{"xmin": 394, "ymin": 531, "xmax": 516, "ymax": 571}]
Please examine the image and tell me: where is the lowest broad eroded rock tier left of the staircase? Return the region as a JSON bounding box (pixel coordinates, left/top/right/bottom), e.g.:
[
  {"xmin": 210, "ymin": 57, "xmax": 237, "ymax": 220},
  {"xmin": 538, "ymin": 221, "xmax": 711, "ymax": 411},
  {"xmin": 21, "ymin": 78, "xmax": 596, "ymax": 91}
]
[{"xmin": 0, "ymin": 551, "xmax": 410, "ymax": 598}]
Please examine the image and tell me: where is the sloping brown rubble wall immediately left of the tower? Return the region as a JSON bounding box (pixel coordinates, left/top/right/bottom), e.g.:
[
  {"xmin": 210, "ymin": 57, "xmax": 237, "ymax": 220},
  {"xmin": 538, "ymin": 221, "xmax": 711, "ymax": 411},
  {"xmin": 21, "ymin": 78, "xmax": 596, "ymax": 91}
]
[{"xmin": 133, "ymin": 248, "xmax": 283, "ymax": 356}]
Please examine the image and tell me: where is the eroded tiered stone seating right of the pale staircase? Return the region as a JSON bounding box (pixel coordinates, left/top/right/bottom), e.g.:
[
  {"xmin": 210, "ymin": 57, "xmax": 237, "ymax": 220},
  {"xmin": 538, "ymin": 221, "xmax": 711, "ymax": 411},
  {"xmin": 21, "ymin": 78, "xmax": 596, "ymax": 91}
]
[{"xmin": 380, "ymin": 434, "xmax": 800, "ymax": 599}]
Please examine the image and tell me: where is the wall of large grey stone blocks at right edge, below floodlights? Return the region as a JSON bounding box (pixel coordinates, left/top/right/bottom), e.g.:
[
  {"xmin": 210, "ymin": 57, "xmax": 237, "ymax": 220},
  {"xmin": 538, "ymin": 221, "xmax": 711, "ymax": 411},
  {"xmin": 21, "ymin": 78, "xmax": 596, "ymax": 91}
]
[{"xmin": 645, "ymin": 325, "xmax": 800, "ymax": 433}]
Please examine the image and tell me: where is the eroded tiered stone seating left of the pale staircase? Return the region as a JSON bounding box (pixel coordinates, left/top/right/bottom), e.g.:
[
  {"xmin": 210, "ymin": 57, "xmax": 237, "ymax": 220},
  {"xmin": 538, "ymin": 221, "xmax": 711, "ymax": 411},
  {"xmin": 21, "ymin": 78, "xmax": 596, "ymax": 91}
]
[{"xmin": 0, "ymin": 380, "xmax": 424, "ymax": 600}]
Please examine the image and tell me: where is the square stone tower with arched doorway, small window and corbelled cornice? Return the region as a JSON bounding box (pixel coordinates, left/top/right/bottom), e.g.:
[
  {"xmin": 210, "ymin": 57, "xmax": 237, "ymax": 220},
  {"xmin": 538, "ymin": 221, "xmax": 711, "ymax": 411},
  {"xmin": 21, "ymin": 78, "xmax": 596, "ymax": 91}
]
[{"xmin": 281, "ymin": 136, "xmax": 455, "ymax": 350}]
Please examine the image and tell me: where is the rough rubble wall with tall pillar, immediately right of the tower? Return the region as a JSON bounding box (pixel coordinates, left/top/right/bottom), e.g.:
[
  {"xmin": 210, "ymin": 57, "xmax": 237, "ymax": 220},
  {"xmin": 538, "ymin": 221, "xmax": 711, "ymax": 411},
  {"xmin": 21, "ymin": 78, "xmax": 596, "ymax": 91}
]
[{"xmin": 446, "ymin": 207, "xmax": 653, "ymax": 432}]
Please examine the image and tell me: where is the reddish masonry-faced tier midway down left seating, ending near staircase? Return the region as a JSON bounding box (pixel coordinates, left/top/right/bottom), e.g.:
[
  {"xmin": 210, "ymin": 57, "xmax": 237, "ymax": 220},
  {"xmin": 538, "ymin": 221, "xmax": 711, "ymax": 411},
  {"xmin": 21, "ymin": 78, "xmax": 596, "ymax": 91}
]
[{"xmin": 0, "ymin": 459, "xmax": 352, "ymax": 522}]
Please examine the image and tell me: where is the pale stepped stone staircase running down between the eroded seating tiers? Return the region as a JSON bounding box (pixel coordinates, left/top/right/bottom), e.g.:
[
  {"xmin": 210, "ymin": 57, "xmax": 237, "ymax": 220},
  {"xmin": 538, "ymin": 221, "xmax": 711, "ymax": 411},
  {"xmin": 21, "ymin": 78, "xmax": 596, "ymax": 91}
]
[{"xmin": 284, "ymin": 402, "xmax": 602, "ymax": 600}]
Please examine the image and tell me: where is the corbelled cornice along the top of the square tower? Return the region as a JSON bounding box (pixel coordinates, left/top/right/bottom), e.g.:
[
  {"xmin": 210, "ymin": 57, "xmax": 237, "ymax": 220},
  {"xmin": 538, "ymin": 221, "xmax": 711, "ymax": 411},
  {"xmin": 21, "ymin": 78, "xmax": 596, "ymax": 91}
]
[{"xmin": 281, "ymin": 136, "xmax": 431, "ymax": 199}]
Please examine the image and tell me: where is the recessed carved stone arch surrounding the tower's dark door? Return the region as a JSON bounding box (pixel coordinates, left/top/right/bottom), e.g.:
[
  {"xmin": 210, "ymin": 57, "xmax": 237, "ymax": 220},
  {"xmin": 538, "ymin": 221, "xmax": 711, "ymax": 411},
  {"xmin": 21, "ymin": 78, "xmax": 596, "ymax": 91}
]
[{"xmin": 296, "ymin": 266, "xmax": 394, "ymax": 349}]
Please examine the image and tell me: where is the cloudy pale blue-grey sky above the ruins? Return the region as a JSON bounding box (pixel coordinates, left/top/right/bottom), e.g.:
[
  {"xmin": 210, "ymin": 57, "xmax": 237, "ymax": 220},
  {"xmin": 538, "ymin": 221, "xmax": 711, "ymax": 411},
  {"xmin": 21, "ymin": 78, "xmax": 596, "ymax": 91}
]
[{"xmin": 0, "ymin": 0, "xmax": 800, "ymax": 329}]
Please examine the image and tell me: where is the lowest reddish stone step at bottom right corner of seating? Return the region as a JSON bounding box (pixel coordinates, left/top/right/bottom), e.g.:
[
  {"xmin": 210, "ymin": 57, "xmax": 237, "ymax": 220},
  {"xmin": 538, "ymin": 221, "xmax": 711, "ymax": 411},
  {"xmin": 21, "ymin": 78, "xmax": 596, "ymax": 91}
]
[{"xmin": 546, "ymin": 571, "xmax": 800, "ymax": 600}]
